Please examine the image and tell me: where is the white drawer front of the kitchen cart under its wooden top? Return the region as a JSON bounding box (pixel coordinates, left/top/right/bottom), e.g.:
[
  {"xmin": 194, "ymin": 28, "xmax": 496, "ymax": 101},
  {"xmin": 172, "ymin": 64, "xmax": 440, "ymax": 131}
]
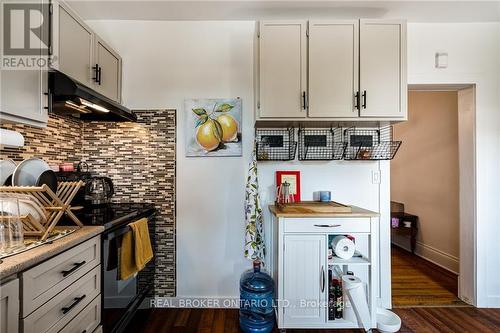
[{"xmin": 283, "ymin": 218, "xmax": 370, "ymax": 234}]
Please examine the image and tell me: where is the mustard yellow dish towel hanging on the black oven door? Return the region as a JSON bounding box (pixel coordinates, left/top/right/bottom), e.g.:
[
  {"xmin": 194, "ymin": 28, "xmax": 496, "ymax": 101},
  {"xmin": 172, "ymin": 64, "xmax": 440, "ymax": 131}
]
[{"xmin": 118, "ymin": 218, "xmax": 153, "ymax": 280}]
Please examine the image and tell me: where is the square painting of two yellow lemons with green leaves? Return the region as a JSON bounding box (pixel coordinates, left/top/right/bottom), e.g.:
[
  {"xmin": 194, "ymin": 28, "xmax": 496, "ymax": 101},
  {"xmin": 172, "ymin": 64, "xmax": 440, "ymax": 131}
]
[{"xmin": 184, "ymin": 98, "xmax": 242, "ymax": 156}]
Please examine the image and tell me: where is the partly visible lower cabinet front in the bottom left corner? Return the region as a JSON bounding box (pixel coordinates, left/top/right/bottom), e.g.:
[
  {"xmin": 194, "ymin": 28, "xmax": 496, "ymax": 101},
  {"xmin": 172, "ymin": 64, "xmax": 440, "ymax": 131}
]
[{"xmin": 0, "ymin": 279, "xmax": 19, "ymax": 333}]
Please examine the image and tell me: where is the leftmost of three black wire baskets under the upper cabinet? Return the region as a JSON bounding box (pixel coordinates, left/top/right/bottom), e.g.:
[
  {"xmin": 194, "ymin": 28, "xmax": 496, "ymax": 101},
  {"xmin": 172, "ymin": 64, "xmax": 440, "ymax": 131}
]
[{"xmin": 255, "ymin": 127, "xmax": 297, "ymax": 161}]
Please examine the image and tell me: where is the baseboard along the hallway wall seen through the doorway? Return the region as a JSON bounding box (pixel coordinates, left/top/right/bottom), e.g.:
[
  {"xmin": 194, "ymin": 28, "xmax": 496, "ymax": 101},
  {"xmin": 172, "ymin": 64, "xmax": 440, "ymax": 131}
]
[{"xmin": 392, "ymin": 235, "xmax": 460, "ymax": 275}]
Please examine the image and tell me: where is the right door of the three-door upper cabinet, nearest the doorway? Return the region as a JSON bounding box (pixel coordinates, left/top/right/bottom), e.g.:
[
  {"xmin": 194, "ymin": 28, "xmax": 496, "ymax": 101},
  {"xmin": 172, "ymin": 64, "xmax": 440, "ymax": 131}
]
[{"xmin": 360, "ymin": 20, "xmax": 407, "ymax": 118}]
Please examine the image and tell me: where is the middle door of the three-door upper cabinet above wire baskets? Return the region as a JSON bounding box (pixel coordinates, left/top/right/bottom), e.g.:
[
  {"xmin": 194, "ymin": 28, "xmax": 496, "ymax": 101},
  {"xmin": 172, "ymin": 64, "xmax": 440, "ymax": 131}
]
[{"xmin": 308, "ymin": 20, "xmax": 359, "ymax": 118}]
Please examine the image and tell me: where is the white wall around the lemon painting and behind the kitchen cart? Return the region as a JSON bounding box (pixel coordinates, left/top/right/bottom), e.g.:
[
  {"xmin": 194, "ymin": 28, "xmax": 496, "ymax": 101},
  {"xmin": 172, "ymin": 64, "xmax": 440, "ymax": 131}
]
[{"xmin": 88, "ymin": 21, "xmax": 390, "ymax": 299}]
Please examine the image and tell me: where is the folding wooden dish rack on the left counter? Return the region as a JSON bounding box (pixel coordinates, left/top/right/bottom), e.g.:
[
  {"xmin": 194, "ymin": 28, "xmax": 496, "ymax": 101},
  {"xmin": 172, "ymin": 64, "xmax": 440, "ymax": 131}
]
[{"xmin": 0, "ymin": 180, "xmax": 84, "ymax": 241}]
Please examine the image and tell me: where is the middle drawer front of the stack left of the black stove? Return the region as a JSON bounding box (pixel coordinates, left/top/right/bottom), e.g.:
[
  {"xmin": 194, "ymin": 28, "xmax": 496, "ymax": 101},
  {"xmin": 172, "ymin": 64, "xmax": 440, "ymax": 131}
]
[{"xmin": 23, "ymin": 265, "xmax": 101, "ymax": 333}]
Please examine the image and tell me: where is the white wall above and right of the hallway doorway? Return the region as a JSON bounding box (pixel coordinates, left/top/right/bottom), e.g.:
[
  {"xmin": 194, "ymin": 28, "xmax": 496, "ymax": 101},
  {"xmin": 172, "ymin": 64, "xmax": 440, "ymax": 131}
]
[{"xmin": 408, "ymin": 23, "xmax": 500, "ymax": 307}]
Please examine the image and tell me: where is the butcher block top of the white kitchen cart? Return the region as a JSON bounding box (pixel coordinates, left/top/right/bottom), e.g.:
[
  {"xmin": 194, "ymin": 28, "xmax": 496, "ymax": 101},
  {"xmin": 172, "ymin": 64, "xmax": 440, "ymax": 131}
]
[{"xmin": 269, "ymin": 202, "xmax": 379, "ymax": 218}]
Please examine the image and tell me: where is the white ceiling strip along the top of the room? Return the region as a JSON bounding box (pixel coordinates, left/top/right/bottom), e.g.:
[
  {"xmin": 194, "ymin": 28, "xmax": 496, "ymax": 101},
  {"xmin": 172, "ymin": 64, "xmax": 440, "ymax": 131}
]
[{"xmin": 67, "ymin": 0, "xmax": 500, "ymax": 22}]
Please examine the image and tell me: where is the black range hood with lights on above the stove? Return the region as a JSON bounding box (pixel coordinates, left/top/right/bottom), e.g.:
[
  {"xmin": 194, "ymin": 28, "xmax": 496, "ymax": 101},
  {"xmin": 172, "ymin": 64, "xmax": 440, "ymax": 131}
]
[{"xmin": 49, "ymin": 71, "xmax": 137, "ymax": 121}]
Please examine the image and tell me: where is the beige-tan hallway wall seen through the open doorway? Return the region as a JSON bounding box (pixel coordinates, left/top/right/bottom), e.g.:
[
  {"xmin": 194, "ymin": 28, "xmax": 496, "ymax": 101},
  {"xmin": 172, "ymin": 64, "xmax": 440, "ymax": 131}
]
[{"xmin": 391, "ymin": 91, "xmax": 460, "ymax": 272}]
